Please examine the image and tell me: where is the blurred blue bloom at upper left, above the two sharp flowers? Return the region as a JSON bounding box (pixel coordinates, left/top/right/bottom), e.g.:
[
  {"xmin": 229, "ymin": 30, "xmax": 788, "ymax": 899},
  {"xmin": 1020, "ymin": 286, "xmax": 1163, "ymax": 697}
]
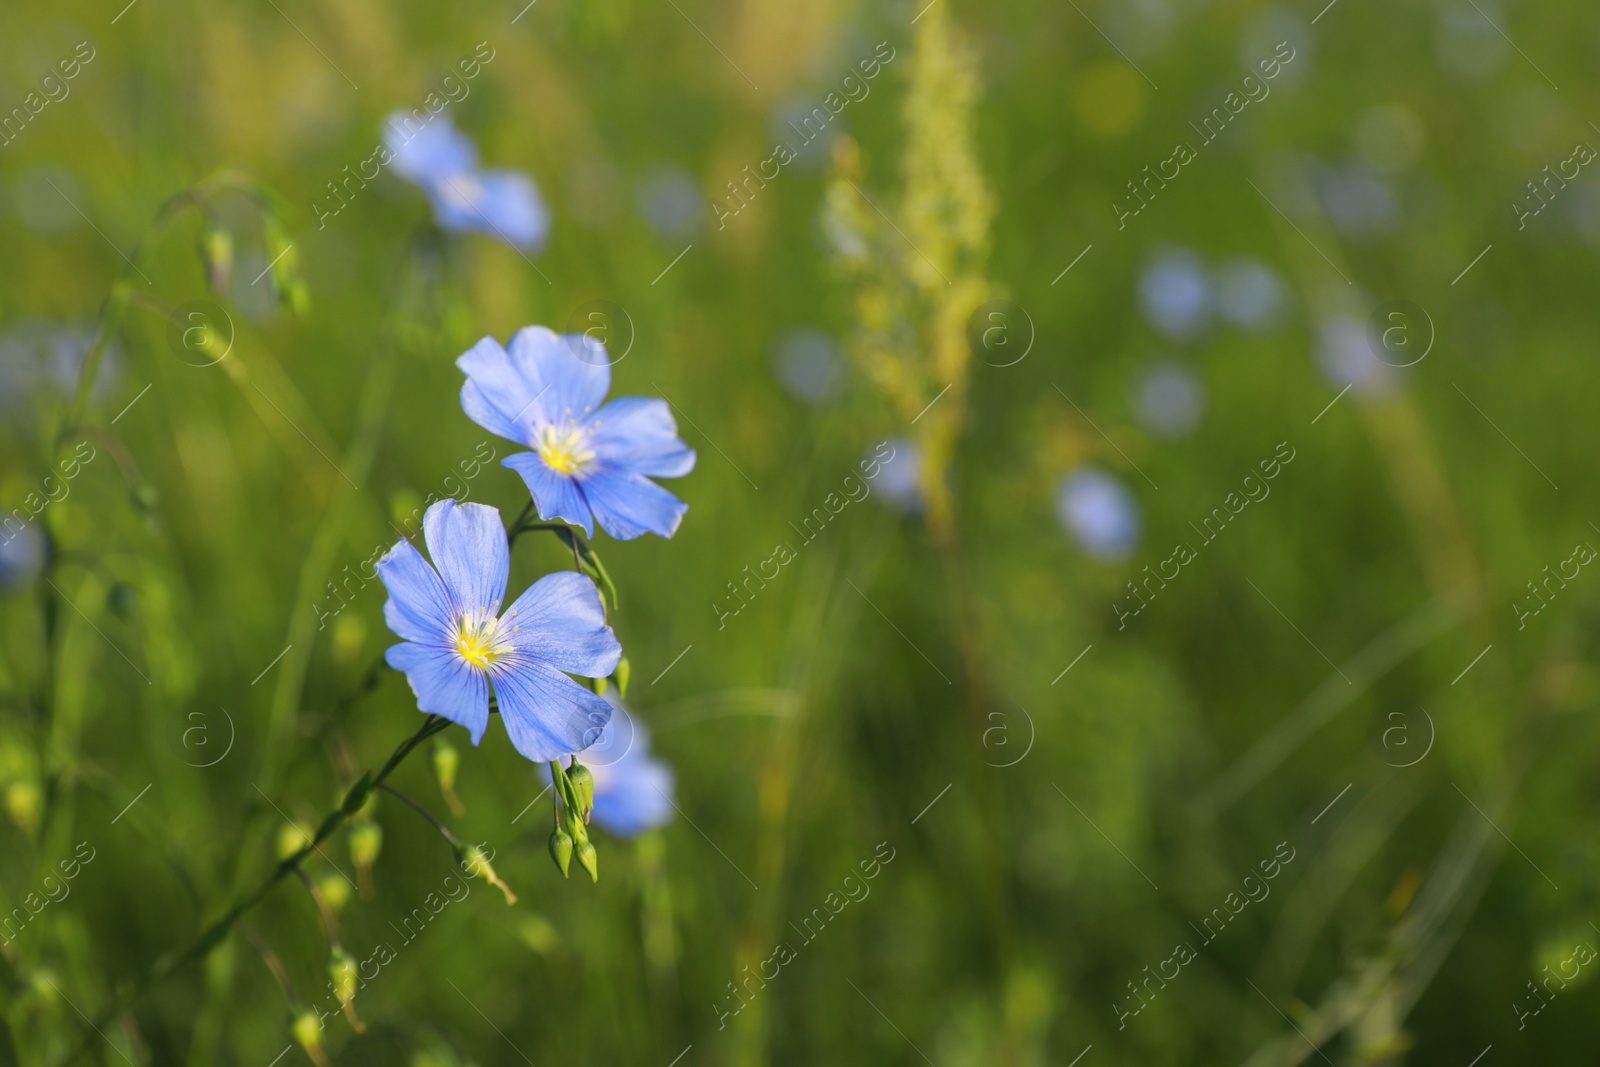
[{"xmin": 384, "ymin": 112, "xmax": 550, "ymax": 250}]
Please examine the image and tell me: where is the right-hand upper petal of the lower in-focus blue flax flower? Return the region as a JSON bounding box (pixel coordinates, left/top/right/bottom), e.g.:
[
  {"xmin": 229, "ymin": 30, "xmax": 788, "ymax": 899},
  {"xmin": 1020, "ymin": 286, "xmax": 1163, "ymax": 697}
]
[{"xmin": 501, "ymin": 571, "xmax": 622, "ymax": 678}]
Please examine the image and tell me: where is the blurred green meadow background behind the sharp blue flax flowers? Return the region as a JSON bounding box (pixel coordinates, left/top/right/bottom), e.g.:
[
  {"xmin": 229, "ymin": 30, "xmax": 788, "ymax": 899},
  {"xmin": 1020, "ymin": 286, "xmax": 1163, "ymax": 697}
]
[{"xmin": 0, "ymin": 0, "xmax": 1600, "ymax": 1067}]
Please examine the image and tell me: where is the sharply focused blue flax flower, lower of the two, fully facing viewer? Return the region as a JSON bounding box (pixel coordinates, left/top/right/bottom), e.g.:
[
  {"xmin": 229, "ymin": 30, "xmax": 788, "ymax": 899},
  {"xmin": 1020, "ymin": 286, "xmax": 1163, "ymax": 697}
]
[{"xmin": 378, "ymin": 499, "xmax": 622, "ymax": 761}]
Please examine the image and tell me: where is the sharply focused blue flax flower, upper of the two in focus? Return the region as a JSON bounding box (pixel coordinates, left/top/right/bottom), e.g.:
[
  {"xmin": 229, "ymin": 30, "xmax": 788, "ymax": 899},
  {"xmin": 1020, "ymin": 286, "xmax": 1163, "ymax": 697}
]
[{"xmin": 456, "ymin": 326, "xmax": 694, "ymax": 541}]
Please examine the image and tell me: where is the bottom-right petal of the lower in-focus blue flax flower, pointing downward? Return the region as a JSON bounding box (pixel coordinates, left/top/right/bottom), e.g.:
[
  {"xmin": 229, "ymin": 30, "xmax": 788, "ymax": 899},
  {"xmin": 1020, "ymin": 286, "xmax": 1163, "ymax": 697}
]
[{"xmin": 490, "ymin": 653, "xmax": 611, "ymax": 763}]
